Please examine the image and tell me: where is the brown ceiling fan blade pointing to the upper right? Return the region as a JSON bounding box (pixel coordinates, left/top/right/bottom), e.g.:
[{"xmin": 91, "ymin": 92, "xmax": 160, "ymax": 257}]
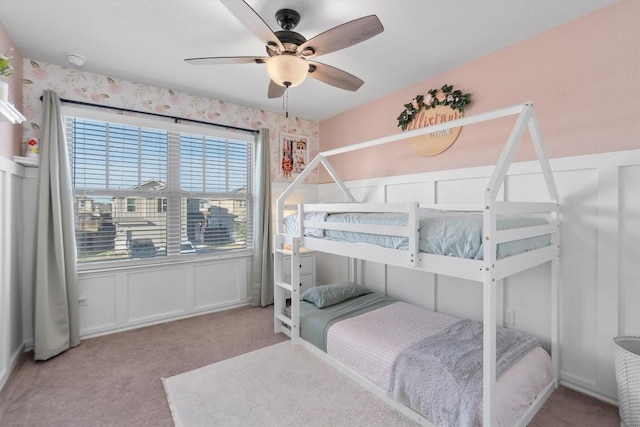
[{"xmin": 298, "ymin": 15, "xmax": 384, "ymax": 58}]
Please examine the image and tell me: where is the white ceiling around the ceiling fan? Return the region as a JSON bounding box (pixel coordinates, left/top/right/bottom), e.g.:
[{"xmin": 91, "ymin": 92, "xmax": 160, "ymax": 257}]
[{"xmin": 0, "ymin": 0, "xmax": 616, "ymax": 121}]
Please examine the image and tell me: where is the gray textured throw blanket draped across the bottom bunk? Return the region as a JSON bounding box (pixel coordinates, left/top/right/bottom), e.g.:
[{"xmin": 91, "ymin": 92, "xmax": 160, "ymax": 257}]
[{"xmin": 389, "ymin": 319, "xmax": 541, "ymax": 426}]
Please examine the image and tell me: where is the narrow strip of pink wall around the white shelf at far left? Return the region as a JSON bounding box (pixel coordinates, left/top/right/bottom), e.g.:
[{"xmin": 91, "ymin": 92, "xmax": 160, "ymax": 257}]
[{"xmin": 0, "ymin": 22, "xmax": 22, "ymax": 159}]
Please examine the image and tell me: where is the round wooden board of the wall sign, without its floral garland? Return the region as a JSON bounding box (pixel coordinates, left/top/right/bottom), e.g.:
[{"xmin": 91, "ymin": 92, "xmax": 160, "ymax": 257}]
[{"xmin": 407, "ymin": 105, "xmax": 464, "ymax": 156}]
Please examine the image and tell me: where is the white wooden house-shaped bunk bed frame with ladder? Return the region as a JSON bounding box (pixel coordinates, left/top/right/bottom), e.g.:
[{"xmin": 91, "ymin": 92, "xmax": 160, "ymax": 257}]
[{"xmin": 274, "ymin": 103, "xmax": 559, "ymax": 426}]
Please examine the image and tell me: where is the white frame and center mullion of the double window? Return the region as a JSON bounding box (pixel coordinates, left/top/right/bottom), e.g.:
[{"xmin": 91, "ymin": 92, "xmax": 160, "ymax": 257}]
[{"xmin": 61, "ymin": 104, "xmax": 257, "ymax": 271}]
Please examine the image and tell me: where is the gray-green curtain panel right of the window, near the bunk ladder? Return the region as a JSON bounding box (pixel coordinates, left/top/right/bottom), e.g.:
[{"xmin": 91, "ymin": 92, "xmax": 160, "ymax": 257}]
[{"xmin": 251, "ymin": 129, "xmax": 273, "ymax": 307}]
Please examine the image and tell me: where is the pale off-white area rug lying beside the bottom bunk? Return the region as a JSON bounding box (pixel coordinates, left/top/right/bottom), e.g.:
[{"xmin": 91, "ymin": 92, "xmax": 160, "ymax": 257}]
[{"xmin": 162, "ymin": 341, "xmax": 416, "ymax": 427}]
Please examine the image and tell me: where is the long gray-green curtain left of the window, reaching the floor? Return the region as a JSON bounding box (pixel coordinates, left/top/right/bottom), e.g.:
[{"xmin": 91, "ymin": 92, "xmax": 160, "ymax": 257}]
[{"xmin": 33, "ymin": 90, "xmax": 80, "ymax": 360}]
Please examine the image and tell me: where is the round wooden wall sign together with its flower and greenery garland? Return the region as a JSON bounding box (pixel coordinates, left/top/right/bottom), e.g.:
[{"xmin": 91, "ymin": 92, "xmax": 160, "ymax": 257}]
[{"xmin": 398, "ymin": 84, "xmax": 471, "ymax": 156}]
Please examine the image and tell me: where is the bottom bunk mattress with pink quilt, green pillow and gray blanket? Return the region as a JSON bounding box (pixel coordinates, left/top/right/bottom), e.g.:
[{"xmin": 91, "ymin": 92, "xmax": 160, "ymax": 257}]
[{"xmin": 300, "ymin": 283, "xmax": 553, "ymax": 426}]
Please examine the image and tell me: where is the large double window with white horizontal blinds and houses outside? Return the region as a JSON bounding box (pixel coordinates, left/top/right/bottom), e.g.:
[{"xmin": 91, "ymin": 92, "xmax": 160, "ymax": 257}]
[{"xmin": 65, "ymin": 109, "xmax": 254, "ymax": 263}]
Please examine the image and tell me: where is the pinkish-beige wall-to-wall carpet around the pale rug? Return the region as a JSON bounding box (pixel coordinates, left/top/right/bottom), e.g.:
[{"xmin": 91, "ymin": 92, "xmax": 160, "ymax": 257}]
[{"xmin": 0, "ymin": 306, "xmax": 620, "ymax": 427}]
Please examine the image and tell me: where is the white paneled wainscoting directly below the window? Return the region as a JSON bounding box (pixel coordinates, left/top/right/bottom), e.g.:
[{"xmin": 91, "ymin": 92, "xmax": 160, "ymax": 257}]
[{"xmin": 79, "ymin": 256, "xmax": 251, "ymax": 337}]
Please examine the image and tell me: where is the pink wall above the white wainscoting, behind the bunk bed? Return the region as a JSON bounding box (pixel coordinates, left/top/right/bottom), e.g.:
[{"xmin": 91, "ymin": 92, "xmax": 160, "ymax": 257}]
[{"xmin": 320, "ymin": 0, "xmax": 640, "ymax": 182}]
